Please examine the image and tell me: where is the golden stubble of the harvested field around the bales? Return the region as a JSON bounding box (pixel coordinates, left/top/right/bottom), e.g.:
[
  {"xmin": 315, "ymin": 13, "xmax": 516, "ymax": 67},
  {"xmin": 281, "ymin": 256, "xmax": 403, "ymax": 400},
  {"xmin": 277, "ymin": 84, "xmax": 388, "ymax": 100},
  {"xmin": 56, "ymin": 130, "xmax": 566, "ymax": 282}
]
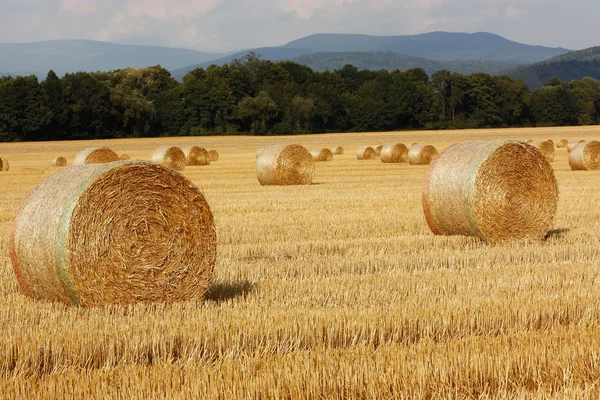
[{"xmin": 0, "ymin": 128, "xmax": 600, "ymax": 399}]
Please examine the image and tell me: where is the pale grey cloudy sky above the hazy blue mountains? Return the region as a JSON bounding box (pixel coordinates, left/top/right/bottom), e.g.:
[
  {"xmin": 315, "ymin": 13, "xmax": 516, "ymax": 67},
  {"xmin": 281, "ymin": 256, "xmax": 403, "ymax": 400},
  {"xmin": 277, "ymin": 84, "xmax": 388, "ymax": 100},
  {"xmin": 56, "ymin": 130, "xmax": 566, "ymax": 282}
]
[{"xmin": 0, "ymin": 0, "xmax": 600, "ymax": 51}]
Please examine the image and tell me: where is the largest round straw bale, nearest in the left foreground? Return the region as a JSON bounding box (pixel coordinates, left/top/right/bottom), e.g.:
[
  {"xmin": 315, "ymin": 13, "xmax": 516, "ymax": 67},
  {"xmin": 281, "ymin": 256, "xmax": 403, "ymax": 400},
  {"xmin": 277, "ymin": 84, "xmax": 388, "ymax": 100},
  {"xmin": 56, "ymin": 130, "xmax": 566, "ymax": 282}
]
[{"xmin": 9, "ymin": 161, "xmax": 217, "ymax": 306}]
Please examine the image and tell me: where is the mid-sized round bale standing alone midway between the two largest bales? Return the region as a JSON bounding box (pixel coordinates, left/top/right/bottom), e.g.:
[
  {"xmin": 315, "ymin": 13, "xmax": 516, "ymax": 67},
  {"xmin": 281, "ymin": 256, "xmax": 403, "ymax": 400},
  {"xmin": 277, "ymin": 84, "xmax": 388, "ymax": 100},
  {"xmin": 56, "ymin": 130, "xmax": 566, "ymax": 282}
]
[{"xmin": 256, "ymin": 144, "xmax": 315, "ymax": 186}]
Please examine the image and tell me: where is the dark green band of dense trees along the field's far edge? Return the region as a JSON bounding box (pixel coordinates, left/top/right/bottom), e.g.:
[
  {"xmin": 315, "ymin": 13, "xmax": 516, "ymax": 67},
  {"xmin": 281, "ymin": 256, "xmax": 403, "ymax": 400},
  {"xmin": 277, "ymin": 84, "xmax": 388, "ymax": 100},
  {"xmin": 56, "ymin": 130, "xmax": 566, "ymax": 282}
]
[{"xmin": 0, "ymin": 54, "xmax": 600, "ymax": 141}]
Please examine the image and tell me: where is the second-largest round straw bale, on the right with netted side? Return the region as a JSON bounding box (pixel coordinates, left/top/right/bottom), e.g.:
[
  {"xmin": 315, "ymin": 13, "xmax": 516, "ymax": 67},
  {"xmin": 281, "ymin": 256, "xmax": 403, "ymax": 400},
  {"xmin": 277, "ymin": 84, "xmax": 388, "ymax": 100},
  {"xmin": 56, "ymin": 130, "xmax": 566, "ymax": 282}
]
[{"xmin": 422, "ymin": 140, "xmax": 558, "ymax": 243}]
